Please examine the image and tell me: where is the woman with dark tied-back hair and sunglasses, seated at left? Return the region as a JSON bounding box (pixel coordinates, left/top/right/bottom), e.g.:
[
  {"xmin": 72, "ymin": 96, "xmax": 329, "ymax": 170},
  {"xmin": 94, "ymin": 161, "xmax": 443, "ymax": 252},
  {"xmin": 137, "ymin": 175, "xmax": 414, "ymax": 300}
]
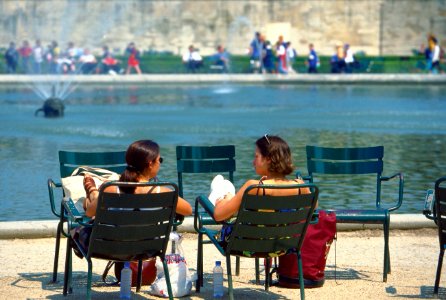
[{"xmin": 84, "ymin": 140, "xmax": 192, "ymax": 217}]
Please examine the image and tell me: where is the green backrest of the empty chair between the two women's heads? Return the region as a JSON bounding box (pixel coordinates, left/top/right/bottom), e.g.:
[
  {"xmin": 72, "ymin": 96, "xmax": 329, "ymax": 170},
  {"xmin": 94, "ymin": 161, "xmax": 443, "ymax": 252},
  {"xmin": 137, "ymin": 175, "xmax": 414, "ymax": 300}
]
[{"xmin": 176, "ymin": 145, "xmax": 235, "ymax": 197}]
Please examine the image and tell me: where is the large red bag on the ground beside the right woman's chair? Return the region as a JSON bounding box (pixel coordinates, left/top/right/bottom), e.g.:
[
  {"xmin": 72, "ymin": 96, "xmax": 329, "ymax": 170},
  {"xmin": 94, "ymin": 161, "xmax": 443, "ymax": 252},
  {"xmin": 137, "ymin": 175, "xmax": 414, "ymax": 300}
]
[{"xmin": 272, "ymin": 210, "xmax": 336, "ymax": 288}]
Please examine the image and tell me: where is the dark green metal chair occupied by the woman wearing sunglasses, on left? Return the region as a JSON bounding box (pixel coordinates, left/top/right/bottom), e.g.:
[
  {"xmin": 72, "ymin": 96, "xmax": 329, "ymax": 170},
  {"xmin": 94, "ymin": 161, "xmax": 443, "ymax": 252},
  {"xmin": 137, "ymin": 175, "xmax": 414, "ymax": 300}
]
[{"xmin": 63, "ymin": 181, "xmax": 178, "ymax": 299}]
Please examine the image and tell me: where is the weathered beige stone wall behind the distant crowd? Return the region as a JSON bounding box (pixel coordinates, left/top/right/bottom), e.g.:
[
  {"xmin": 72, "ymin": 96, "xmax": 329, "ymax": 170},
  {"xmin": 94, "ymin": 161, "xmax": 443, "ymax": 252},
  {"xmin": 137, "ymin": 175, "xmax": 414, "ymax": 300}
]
[{"xmin": 0, "ymin": 0, "xmax": 446, "ymax": 55}]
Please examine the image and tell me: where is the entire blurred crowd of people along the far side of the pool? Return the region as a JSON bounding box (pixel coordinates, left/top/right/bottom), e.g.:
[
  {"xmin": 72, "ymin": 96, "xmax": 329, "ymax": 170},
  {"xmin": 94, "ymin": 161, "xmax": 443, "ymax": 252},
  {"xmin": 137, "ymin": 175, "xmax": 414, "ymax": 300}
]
[{"xmin": 4, "ymin": 32, "xmax": 444, "ymax": 74}]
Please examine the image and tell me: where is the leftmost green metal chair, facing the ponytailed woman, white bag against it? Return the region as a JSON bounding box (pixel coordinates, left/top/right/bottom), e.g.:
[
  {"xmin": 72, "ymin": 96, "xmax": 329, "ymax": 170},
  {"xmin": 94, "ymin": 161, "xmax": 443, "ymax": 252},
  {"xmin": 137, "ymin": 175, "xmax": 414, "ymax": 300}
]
[{"xmin": 48, "ymin": 151, "xmax": 126, "ymax": 282}]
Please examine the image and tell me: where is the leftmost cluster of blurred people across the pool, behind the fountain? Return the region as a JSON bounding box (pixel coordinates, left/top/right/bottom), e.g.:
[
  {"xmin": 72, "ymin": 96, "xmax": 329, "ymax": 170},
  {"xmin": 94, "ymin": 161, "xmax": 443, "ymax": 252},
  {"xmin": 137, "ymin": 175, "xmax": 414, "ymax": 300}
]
[{"xmin": 4, "ymin": 40, "xmax": 142, "ymax": 74}]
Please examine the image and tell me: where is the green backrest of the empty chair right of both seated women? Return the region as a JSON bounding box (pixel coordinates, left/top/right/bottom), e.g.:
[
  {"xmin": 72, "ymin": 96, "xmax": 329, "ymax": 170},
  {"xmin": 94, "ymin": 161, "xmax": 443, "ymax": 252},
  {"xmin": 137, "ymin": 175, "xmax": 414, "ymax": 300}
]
[{"xmin": 306, "ymin": 146, "xmax": 384, "ymax": 207}]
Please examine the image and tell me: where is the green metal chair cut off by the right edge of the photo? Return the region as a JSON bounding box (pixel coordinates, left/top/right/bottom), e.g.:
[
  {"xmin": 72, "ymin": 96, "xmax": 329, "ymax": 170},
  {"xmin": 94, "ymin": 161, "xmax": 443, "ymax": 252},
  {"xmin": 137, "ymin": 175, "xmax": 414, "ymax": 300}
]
[{"xmin": 423, "ymin": 177, "xmax": 446, "ymax": 294}]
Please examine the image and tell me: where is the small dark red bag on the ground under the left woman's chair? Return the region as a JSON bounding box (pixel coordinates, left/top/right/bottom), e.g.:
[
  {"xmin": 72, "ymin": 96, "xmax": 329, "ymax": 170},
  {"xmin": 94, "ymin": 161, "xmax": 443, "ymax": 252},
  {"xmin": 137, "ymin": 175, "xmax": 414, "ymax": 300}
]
[{"xmin": 102, "ymin": 258, "xmax": 156, "ymax": 287}]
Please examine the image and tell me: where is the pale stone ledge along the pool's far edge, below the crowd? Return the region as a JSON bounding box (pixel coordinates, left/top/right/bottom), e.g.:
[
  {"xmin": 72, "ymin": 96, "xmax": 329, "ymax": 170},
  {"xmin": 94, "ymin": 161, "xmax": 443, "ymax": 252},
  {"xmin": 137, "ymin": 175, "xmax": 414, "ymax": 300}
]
[{"xmin": 0, "ymin": 73, "xmax": 446, "ymax": 85}]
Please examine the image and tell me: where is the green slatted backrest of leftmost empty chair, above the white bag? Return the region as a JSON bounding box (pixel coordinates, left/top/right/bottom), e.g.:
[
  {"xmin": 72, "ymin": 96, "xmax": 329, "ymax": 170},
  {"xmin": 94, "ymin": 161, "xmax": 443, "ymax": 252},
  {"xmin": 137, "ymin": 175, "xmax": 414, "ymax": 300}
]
[{"xmin": 59, "ymin": 151, "xmax": 127, "ymax": 178}]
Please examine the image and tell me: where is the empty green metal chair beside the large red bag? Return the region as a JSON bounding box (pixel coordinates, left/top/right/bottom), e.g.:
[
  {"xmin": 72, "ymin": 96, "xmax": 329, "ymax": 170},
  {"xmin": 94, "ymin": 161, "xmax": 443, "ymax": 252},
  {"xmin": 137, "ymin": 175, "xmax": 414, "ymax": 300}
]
[{"xmin": 304, "ymin": 146, "xmax": 404, "ymax": 282}]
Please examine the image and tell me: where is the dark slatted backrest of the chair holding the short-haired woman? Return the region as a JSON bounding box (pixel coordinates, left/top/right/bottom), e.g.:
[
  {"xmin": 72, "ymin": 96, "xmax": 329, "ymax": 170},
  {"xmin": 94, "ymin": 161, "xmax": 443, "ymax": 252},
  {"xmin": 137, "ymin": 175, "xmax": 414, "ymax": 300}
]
[{"xmin": 226, "ymin": 184, "xmax": 319, "ymax": 254}]
